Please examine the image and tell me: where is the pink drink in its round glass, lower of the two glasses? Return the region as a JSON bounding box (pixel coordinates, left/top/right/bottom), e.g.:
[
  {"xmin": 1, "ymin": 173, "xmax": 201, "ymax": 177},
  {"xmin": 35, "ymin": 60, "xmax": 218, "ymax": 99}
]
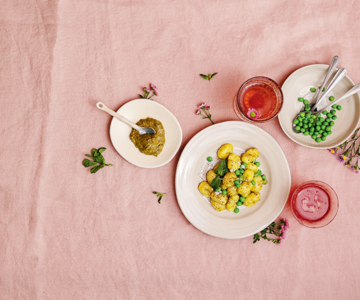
[{"xmin": 291, "ymin": 181, "xmax": 339, "ymax": 228}]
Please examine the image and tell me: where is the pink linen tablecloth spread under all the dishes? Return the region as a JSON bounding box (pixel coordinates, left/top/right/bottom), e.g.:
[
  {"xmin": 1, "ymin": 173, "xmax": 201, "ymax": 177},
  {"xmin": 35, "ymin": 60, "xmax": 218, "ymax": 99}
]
[{"xmin": 0, "ymin": 0, "xmax": 360, "ymax": 300}]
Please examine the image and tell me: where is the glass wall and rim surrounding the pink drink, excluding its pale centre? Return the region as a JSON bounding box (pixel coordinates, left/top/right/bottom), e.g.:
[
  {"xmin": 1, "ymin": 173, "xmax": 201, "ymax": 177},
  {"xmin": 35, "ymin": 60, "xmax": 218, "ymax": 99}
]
[{"xmin": 290, "ymin": 180, "xmax": 339, "ymax": 228}]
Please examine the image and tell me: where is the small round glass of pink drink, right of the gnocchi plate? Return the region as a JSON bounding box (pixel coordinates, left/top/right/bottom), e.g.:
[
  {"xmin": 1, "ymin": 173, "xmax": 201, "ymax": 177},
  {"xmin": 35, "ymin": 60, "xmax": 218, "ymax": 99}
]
[{"xmin": 290, "ymin": 180, "xmax": 339, "ymax": 228}]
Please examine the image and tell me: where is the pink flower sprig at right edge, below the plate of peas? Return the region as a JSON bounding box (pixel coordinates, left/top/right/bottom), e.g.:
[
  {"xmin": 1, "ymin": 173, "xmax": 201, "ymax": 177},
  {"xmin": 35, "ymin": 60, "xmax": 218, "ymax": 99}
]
[{"xmin": 328, "ymin": 128, "xmax": 360, "ymax": 174}]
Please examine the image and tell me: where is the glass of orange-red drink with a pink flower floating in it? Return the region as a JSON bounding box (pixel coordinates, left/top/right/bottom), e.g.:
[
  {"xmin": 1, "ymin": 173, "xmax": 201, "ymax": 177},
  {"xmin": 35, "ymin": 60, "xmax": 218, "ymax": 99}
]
[{"xmin": 234, "ymin": 76, "xmax": 284, "ymax": 123}]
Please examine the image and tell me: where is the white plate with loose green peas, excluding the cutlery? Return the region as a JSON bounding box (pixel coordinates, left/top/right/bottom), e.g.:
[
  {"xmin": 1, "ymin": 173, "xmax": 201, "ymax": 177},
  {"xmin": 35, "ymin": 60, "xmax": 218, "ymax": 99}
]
[{"xmin": 279, "ymin": 64, "xmax": 360, "ymax": 149}]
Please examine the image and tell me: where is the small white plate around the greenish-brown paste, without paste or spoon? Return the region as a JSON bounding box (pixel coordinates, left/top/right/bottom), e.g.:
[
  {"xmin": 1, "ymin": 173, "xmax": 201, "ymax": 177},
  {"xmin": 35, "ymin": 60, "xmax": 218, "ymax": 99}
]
[{"xmin": 110, "ymin": 99, "xmax": 182, "ymax": 168}]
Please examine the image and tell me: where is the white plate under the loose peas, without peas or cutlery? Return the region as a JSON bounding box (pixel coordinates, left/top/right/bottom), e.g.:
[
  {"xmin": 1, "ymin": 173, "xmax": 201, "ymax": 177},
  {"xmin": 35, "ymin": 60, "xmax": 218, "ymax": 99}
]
[{"xmin": 279, "ymin": 64, "xmax": 360, "ymax": 149}]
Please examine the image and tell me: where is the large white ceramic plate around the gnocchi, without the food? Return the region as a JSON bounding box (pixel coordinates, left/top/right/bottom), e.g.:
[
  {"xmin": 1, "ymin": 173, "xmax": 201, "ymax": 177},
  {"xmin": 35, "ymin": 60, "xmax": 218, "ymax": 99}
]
[{"xmin": 175, "ymin": 121, "xmax": 291, "ymax": 239}]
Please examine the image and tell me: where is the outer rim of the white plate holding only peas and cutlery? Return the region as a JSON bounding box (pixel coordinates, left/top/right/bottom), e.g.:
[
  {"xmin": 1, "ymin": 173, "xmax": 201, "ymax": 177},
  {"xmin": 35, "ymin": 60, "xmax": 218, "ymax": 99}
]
[{"xmin": 278, "ymin": 64, "xmax": 360, "ymax": 150}]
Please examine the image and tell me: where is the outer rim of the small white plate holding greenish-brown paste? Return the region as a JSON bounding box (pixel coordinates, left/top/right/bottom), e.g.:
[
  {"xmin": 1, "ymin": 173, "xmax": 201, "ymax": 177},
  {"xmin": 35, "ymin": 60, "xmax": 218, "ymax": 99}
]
[{"xmin": 109, "ymin": 99, "xmax": 183, "ymax": 169}]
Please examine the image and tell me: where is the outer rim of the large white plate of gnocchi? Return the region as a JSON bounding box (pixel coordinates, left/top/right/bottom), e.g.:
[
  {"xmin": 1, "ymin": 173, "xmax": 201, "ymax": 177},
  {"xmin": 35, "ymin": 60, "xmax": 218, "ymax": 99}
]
[{"xmin": 175, "ymin": 121, "xmax": 291, "ymax": 239}]
